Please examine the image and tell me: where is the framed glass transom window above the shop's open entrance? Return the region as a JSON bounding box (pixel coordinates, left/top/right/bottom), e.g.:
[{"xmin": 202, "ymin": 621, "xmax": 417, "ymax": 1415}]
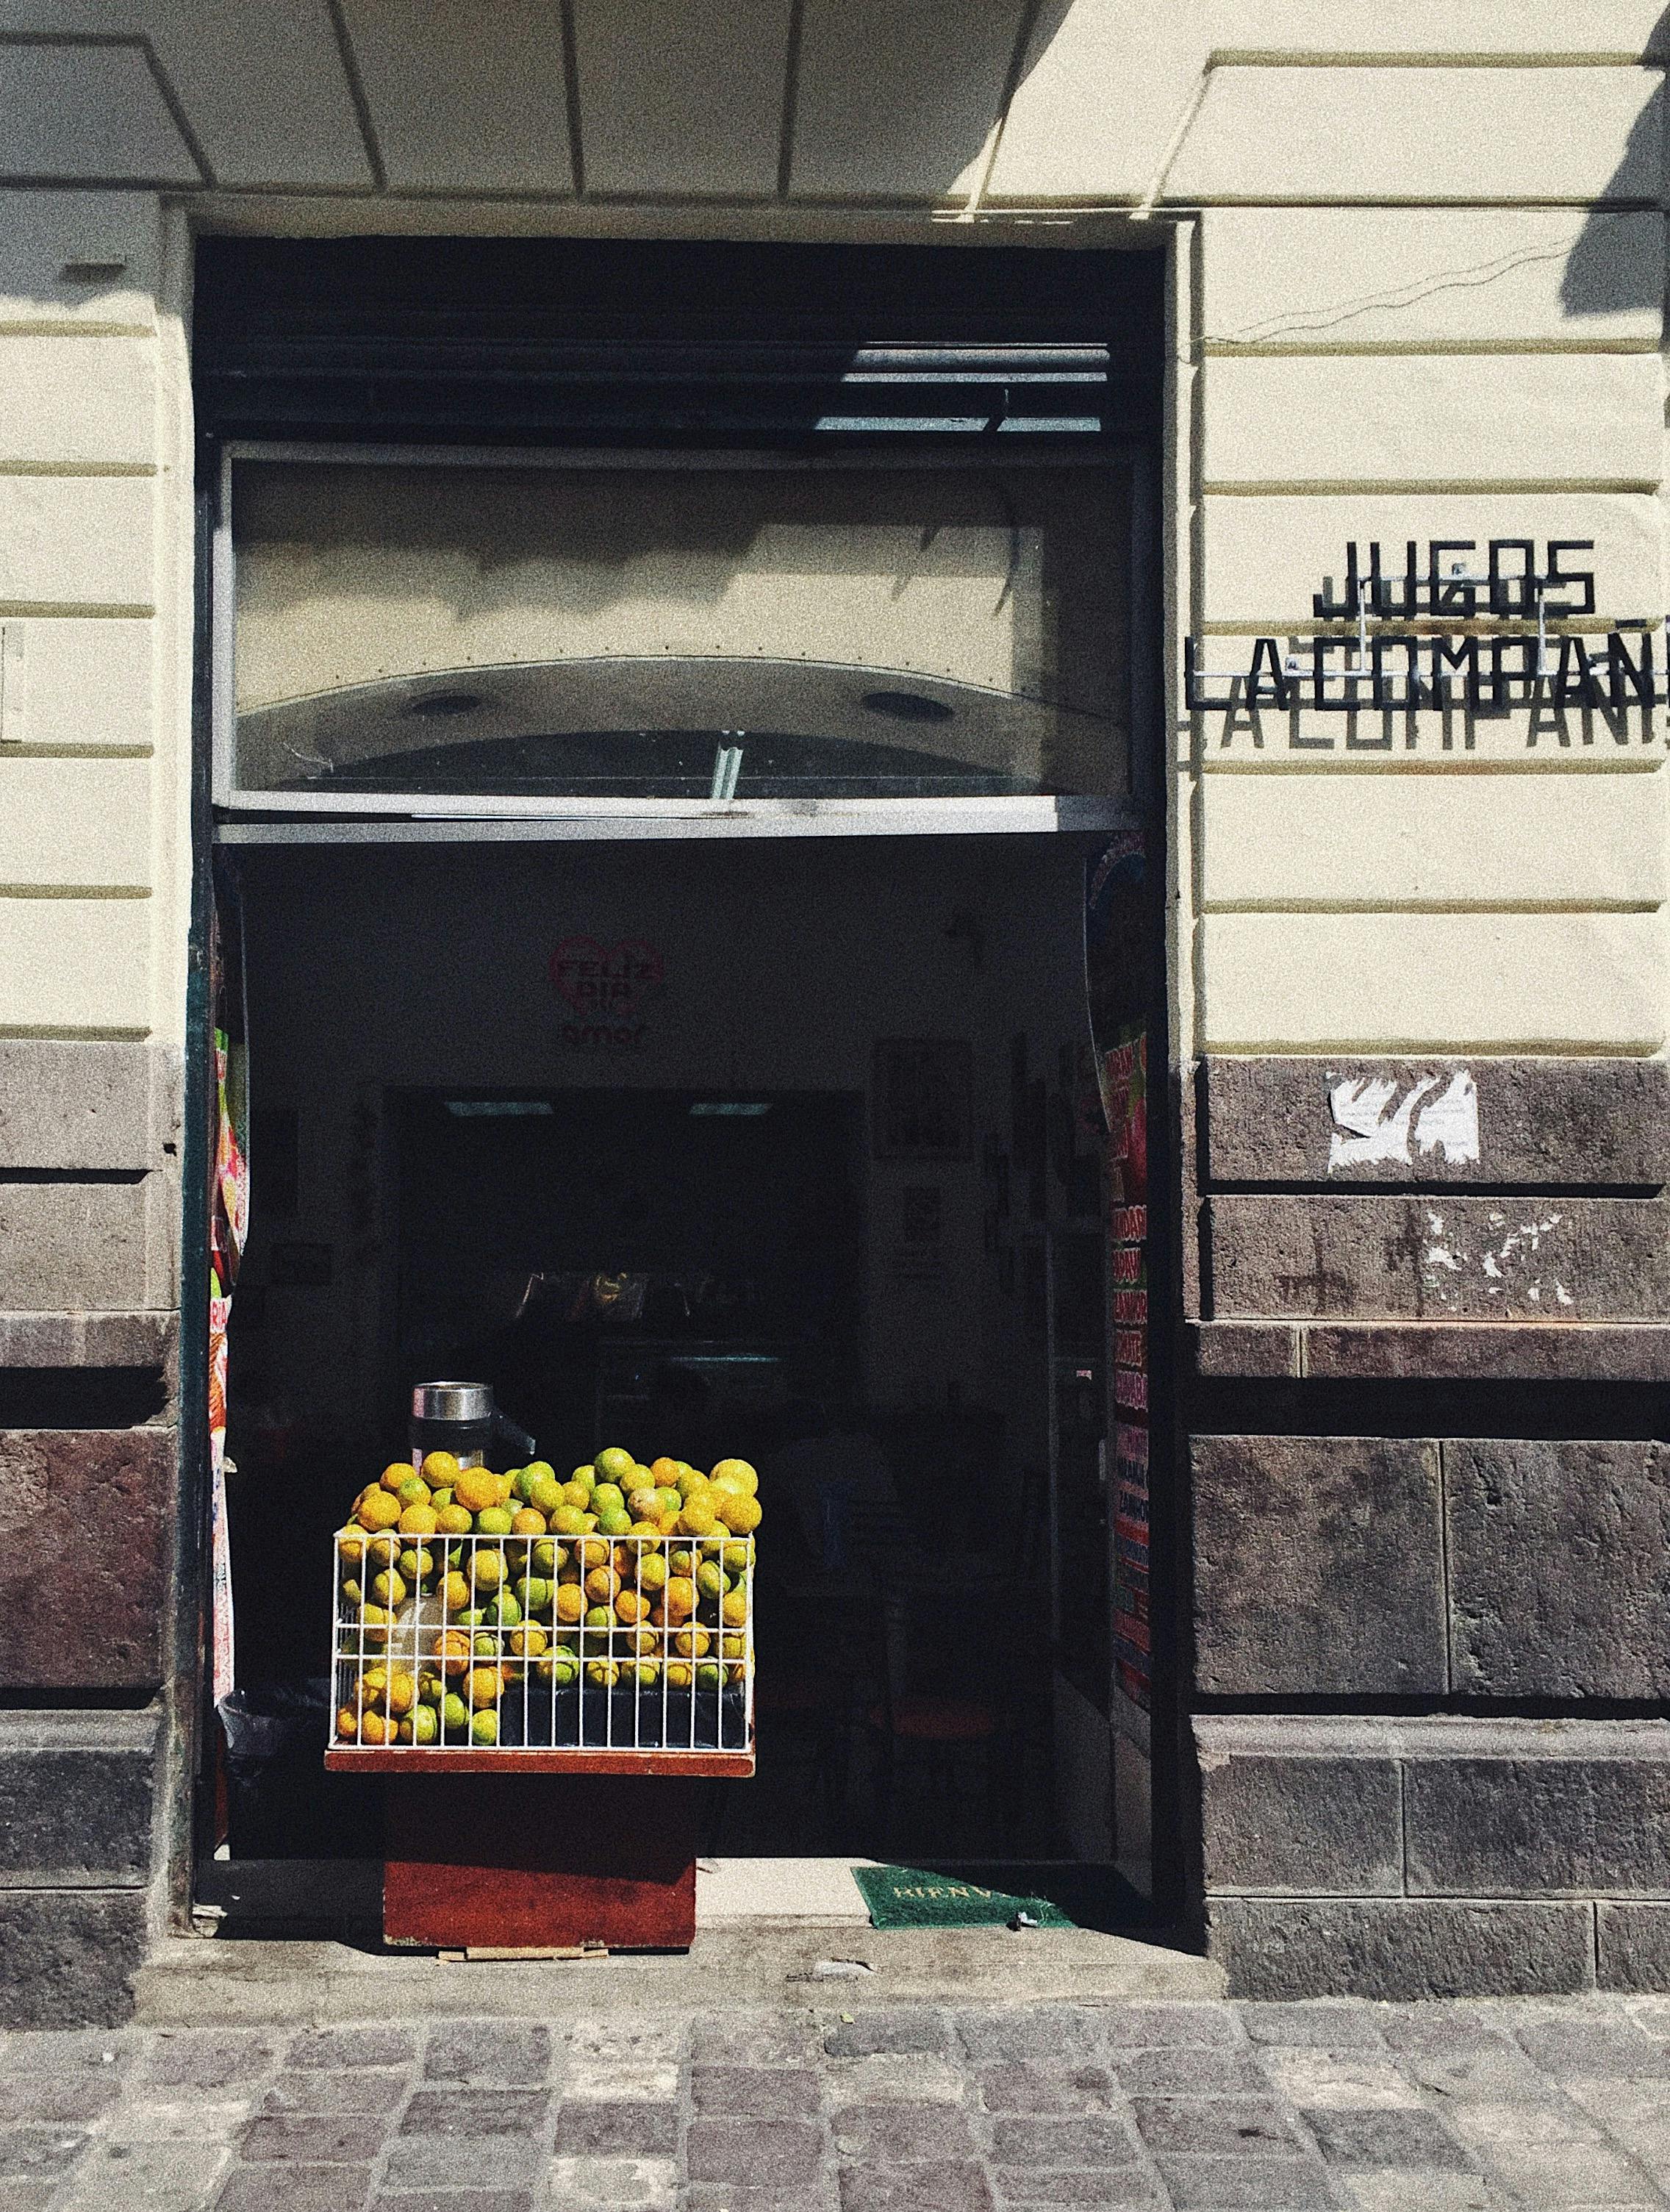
[{"xmin": 217, "ymin": 456, "xmax": 1130, "ymax": 812}]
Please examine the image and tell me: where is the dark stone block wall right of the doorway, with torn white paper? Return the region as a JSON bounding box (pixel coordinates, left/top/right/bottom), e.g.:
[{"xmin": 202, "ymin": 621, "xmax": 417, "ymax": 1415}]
[{"xmin": 1188, "ymin": 1057, "xmax": 1670, "ymax": 1997}]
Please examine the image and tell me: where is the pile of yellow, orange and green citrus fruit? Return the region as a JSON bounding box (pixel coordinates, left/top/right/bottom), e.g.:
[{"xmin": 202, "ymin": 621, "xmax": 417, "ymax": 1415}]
[{"xmin": 336, "ymin": 1447, "xmax": 761, "ymax": 1750}]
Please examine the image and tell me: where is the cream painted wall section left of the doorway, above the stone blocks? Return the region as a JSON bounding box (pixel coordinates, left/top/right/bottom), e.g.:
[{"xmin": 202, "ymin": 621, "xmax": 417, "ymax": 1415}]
[{"xmin": 0, "ymin": 193, "xmax": 190, "ymax": 1042}]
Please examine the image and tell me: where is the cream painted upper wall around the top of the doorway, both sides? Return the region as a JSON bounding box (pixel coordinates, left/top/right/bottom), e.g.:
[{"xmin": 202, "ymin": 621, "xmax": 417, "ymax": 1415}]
[{"xmin": 0, "ymin": 0, "xmax": 1670, "ymax": 1084}]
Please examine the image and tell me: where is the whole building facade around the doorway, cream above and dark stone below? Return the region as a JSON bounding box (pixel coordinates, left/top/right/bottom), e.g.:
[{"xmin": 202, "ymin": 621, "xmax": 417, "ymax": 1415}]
[{"xmin": 0, "ymin": 0, "xmax": 1670, "ymax": 2019}]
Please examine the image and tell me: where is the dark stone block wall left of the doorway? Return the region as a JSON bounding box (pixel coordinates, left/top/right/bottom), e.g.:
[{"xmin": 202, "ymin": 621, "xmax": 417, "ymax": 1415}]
[{"xmin": 0, "ymin": 1037, "xmax": 179, "ymax": 2024}]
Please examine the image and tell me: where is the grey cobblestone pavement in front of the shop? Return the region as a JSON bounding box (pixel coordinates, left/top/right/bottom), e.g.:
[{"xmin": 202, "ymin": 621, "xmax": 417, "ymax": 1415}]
[{"xmin": 0, "ymin": 1997, "xmax": 1670, "ymax": 2212}]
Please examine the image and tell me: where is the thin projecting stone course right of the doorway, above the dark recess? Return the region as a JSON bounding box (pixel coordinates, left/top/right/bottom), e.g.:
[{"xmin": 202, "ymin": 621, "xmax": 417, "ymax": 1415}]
[{"xmin": 1188, "ymin": 1320, "xmax": 1670, "ymax": 1383}]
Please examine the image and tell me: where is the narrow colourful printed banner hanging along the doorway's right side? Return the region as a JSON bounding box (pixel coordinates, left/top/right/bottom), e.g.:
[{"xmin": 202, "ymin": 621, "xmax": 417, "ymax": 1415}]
[{"xmin": 1084, "ymin": 829, "xmax": 1153, "ymax": 1710}]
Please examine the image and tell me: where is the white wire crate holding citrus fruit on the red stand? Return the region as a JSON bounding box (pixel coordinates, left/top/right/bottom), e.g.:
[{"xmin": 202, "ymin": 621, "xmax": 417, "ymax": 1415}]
[{"xmin": 329, "ymin": 1528, "xmax": 754, "ymax": 1767}]
